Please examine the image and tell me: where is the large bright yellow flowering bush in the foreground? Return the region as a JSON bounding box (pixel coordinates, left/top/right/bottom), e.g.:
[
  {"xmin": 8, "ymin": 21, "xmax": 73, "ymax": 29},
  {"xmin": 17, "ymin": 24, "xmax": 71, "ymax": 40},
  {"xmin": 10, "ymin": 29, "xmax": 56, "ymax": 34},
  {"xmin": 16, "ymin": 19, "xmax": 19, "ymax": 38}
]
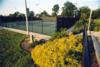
[{"xmin": 31, "ymin": 34, "xmax": 83, "ymax": 67}]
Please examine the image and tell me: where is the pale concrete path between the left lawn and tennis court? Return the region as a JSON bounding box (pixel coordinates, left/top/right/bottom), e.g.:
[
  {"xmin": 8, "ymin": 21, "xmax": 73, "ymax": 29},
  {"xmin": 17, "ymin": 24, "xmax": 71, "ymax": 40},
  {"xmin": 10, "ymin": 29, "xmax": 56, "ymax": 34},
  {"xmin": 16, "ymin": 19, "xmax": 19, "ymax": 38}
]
[{"xmin": 0, "ymin": 26, "xmax": 51, "ymax": 40}]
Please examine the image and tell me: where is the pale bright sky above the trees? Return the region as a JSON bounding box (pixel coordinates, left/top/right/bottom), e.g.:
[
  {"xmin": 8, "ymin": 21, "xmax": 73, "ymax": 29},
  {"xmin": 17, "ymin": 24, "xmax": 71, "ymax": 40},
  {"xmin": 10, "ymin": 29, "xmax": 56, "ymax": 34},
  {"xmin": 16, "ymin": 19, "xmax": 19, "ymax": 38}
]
[{"xmin": 0, "ymin": 0, "xmax": 100, "ymax": 15}]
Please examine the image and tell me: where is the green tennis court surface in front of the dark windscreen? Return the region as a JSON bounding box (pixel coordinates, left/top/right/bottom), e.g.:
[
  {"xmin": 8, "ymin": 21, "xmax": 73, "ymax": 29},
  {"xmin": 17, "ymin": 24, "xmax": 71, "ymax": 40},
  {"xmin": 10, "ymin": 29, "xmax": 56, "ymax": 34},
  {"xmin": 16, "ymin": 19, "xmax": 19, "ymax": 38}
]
[{"xmin": 0, "ymin": 21, "xmax": 56, "ymax": 35}]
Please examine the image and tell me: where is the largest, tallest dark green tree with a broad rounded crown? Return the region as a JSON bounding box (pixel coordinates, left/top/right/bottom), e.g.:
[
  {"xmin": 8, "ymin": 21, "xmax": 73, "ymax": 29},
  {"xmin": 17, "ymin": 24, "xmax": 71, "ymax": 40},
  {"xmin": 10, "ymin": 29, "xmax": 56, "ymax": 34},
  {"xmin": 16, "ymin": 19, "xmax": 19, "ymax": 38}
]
[{"xmin": 61, "ymin": 1, "xmax": 77, "ymax": 16}]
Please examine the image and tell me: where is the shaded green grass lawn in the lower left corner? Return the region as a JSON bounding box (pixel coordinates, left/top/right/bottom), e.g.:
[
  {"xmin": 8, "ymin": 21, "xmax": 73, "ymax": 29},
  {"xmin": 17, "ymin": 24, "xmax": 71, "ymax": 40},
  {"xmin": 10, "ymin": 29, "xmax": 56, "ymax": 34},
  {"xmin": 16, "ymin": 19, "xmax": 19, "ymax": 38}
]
[{"xmin": 0, "ymin": 30, "xmax": 34, "ymax": 67}]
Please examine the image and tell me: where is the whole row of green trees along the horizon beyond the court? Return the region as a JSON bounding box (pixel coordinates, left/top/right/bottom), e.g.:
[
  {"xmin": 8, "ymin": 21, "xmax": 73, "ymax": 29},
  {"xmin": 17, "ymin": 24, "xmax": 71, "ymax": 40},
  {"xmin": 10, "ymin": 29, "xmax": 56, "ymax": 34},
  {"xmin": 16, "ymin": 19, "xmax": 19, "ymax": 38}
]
[{"xmin": 0, "ymin": 1, "xmax": 100, "ymax": 19}]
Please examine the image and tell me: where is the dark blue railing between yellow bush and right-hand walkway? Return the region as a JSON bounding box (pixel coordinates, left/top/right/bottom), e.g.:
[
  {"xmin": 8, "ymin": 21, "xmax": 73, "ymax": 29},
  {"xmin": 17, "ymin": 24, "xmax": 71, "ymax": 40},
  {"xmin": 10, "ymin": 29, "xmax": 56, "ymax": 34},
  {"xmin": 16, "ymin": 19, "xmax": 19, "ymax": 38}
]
[{"xmin": 83, "ymin": 25, "xmax": 91, "ymax": 67}]
